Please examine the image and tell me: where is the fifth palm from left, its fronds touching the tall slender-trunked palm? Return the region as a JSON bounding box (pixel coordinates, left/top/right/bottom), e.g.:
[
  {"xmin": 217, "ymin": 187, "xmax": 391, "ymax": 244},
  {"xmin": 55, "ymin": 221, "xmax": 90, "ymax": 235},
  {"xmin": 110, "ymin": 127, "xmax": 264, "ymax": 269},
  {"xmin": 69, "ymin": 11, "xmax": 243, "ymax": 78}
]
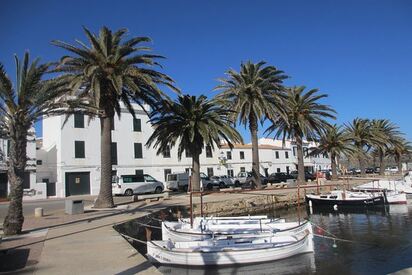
[{"xmin": 266, "ymin": 86, "xmax": 336, "ymax": 182}]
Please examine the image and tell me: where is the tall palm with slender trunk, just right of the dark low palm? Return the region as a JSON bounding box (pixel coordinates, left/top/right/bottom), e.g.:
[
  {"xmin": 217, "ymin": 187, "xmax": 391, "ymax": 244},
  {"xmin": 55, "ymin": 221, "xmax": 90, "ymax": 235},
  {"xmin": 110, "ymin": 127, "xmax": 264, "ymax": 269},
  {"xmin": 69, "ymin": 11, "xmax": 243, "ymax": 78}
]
[{"xmin": 215, "ymin": 61, "xmax": 287, "ymax": 188}]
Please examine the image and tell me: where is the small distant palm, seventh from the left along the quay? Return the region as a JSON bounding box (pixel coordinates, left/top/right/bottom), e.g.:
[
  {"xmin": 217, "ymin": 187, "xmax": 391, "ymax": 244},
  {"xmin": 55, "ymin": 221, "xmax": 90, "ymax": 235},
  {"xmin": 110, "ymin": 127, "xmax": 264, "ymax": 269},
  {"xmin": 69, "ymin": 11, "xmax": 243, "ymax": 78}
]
[{"xmin": 345, "ymin": 118, "xmax": 376, "ymax": 176}]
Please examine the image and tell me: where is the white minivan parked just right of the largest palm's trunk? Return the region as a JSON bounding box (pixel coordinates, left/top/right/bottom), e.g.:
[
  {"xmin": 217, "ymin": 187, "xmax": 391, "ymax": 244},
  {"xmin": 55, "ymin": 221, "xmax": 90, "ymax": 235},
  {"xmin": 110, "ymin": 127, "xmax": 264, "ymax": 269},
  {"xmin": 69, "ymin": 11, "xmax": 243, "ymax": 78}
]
[{"xmin": 112, "ymin": 174, "xmax": 164, "ymax": 196}]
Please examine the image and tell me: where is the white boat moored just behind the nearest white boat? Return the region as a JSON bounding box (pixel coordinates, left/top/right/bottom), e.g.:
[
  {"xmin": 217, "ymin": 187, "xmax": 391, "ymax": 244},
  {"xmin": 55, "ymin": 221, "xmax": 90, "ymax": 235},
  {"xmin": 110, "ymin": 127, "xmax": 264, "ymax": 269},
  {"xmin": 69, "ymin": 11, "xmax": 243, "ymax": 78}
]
[{"xmin": 162, "ymin": 221, "xmax": 312, "ymax": 242}]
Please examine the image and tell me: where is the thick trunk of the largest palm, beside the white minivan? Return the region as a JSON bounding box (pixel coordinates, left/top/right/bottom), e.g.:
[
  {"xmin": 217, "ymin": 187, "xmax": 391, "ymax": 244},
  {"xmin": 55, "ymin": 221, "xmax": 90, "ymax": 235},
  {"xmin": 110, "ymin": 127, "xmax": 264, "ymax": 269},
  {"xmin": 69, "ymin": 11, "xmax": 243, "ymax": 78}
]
[{"xmin": 94, "ymin": 116, "xmax": 114, "ymax": 208}]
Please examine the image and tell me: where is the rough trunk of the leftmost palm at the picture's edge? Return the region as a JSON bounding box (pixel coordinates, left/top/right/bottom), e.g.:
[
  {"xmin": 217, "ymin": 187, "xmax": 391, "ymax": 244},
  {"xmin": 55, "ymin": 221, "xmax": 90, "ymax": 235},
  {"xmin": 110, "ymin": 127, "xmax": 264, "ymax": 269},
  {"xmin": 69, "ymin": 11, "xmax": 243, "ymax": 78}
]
[{"xmin": 3, "ymin": 125, "xmax": 27, "ymax": 235}]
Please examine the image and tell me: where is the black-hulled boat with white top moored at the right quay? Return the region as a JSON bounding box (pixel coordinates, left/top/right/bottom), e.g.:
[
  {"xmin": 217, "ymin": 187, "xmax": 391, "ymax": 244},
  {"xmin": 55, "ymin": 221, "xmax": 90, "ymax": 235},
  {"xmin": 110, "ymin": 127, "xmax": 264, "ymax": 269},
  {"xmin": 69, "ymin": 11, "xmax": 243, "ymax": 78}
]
[{"xmin": 306, "ymin": 191, "xmax": 385, "ymax": 208}]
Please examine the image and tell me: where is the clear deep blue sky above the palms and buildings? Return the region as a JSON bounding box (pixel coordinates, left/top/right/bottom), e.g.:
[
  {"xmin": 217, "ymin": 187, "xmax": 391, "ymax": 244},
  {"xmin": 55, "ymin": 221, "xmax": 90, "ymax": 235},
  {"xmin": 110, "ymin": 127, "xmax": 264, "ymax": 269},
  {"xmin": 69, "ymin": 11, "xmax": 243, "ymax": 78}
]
[{"xmin": 0, "ymin": 0, "xmax": 412, "ymax": 141}]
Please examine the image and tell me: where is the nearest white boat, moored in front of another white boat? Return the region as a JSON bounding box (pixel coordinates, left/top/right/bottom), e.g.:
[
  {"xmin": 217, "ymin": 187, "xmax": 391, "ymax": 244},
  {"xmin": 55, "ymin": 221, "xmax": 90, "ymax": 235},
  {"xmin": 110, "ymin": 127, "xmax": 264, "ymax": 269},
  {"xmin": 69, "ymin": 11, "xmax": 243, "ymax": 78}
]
[{"xmin": 147, "ymin": 231, "xmax": 313, "ymax": 266}]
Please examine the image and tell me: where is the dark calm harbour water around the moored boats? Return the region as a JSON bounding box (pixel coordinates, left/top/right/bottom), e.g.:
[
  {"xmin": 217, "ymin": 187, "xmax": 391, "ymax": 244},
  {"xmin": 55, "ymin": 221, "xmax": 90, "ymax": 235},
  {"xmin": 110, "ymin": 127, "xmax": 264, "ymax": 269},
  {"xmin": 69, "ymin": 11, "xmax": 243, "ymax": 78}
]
[{"xmin": 114, "ymin": 204, "xmax": 412, "ymax": 275}]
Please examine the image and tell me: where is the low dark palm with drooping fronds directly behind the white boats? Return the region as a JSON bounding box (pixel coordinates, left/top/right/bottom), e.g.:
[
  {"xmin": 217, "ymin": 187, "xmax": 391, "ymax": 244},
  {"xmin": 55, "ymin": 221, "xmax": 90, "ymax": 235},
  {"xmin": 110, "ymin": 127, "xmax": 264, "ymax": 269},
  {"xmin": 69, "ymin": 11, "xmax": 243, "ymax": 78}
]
[{"xmin": 146, "ymin": 95, "xmax": 243, "ymax": 191}]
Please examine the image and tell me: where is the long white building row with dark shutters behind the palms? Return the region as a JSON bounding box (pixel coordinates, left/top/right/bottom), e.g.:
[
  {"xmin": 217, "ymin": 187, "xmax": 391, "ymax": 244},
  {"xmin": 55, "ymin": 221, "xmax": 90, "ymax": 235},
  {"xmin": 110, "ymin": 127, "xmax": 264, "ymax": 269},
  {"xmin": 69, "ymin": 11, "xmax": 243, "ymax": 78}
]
[{"xmin": 37, "ymin": 105, "xmax": 332, "ymax": 197}]
